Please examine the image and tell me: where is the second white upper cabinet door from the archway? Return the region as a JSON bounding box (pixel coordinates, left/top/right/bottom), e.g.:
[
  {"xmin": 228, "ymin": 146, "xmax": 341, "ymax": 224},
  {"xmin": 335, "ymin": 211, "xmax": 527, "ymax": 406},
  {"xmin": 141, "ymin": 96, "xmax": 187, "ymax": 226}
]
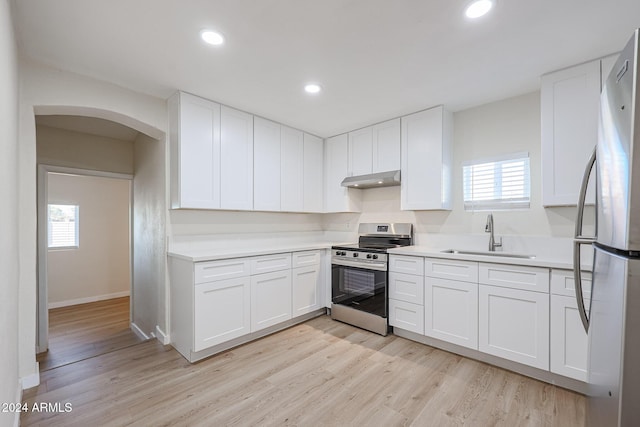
[{"xmin": 220, "ymin": 105, "xmax": 253, "ymax": 210}]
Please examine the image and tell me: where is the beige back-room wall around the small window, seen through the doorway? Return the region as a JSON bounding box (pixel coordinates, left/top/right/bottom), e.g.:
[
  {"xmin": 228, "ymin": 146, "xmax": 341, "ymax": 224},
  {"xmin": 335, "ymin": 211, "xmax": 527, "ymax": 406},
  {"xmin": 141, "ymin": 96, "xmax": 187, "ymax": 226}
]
[{"xmin": 47, "ymin": 173, "xmax": 131, "ymax": 308}]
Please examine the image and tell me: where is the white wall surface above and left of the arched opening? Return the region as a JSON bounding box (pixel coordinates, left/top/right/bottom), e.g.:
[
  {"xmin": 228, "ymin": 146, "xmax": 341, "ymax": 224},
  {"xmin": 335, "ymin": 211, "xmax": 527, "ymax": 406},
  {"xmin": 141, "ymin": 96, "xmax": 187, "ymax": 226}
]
[{"xmin": 18, "ymin": 59, "xmax": 167, "ymax": 384}]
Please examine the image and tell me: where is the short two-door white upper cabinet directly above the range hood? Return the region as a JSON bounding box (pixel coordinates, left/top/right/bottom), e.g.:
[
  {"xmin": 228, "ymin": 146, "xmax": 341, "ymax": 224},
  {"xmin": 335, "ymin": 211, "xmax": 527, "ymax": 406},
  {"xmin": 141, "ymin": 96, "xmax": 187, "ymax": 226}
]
[{"xmin": 349, "ymin": 119, "xmax": 400, "ymax": 176}]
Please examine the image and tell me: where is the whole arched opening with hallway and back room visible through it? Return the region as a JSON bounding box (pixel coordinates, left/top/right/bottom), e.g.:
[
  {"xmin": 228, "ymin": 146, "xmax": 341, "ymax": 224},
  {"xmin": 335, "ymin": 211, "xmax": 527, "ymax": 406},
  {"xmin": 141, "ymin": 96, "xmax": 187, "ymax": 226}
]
[{"xmin": 35, "ymin": 113, "xmax": 165, "ymax": 371}]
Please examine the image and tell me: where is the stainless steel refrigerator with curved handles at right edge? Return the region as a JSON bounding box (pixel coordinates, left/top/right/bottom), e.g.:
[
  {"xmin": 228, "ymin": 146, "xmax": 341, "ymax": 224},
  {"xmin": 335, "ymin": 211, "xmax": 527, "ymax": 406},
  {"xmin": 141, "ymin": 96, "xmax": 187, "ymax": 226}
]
[{"xmin": 574, "ymin": 30, "xmax": 640, "ymax": 426}]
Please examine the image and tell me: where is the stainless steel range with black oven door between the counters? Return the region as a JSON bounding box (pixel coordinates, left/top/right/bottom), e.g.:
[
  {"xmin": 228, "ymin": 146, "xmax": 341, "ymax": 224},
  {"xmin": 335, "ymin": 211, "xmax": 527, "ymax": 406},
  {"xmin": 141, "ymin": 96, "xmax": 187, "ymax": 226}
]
[{"xmin": 331, "ymin": 223, "xmax": 413, "ymax": 335}]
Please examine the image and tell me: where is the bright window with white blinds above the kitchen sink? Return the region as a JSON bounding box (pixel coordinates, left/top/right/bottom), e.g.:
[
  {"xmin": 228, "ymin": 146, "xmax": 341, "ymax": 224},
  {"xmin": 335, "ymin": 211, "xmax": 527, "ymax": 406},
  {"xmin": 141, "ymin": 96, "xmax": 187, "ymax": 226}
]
[{"xmin": 462, "ymin": 153, "xmax": 531, "ymax": 210}]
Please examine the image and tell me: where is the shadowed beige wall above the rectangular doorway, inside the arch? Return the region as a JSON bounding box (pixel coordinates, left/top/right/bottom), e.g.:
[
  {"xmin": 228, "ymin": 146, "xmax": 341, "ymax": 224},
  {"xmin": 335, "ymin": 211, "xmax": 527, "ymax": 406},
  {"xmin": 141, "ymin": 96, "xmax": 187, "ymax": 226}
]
[{"xmin": 36, "ymin": 125, "xmax": 133, "ymax": 174}]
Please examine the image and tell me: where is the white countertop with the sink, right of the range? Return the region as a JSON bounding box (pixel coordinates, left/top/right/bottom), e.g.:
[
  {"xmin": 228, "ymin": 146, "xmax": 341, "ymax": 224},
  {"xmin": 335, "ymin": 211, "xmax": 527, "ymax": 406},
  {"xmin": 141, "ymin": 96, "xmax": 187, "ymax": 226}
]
[{"xmin": 388, "ymin": 246, "xmax": 591, "ymax": 270}]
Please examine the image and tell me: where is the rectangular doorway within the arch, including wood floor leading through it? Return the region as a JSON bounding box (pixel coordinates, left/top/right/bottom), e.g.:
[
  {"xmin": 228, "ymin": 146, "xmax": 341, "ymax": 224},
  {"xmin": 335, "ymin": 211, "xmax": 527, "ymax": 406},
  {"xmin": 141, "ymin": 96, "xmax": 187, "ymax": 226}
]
[{"xmin": 37, "ymin": 166, "xmax": 143, "ymax": 371}]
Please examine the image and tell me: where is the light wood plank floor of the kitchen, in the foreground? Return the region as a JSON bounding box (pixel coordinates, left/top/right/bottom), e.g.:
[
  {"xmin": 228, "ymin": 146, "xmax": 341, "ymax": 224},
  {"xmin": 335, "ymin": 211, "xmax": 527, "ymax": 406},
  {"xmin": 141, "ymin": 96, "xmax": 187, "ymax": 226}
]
[{"xmin": 21, "ymin": 316, "xmax": 585, "ymax": 427}]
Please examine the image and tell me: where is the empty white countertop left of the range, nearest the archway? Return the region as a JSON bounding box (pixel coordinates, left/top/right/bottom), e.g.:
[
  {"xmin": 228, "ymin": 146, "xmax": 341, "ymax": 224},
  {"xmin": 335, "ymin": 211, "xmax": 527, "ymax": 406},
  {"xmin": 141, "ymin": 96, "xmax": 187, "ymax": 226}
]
[{"xmin": 167, "ymin": 242, "xmax": 333, "ymax": 262}]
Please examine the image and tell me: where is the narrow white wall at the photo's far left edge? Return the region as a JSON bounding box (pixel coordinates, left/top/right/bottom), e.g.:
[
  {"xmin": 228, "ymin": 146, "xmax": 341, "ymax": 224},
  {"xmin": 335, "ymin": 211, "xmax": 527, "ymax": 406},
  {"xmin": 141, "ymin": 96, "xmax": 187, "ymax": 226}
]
[{"xmin": 0, "ymin": 0, "xmax": 20, "ymax": 426}]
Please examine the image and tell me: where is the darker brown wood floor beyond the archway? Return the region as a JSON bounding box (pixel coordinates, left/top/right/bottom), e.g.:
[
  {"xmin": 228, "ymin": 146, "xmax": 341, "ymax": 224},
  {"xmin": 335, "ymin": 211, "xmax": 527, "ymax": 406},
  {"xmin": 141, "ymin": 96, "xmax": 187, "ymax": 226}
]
[{"xmin": 37, "ymin": 297, "xmax": 142, "ymax": 372}]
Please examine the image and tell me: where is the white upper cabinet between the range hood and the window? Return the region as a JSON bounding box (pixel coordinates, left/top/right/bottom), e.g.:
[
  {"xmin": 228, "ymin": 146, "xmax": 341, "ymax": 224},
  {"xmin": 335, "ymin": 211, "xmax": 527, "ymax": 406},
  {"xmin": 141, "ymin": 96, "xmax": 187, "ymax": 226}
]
[{"xmin": 400, "ymin": 106, "xmax": 452, "ymax": 210}]
